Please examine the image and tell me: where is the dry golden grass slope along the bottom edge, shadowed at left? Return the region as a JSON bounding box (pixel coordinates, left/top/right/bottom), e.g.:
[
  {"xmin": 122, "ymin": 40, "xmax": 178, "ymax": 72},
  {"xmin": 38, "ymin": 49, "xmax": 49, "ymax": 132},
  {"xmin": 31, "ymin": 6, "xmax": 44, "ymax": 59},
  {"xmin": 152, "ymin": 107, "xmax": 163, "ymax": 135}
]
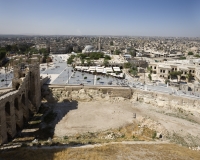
[{"xmin": 0, "ymin": 144, "xmax": 200, "ymax": 160}]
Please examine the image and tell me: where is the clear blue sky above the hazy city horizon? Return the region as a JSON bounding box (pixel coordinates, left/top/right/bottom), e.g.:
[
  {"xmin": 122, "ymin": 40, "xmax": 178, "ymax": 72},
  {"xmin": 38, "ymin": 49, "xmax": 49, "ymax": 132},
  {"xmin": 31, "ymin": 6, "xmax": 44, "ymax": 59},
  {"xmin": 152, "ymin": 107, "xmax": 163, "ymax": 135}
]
[{"xmin": 0, "ymin": 0, "xmax": 200, "ymax": 37}]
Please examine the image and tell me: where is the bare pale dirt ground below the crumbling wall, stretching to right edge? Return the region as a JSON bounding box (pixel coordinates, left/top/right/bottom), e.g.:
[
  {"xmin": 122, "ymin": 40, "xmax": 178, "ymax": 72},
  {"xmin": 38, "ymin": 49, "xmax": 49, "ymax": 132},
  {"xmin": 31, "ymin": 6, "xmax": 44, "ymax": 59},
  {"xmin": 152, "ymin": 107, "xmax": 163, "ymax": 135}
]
[{"xmin": 54, "ymin": 101, "xmax": 200, "ymax": 145}]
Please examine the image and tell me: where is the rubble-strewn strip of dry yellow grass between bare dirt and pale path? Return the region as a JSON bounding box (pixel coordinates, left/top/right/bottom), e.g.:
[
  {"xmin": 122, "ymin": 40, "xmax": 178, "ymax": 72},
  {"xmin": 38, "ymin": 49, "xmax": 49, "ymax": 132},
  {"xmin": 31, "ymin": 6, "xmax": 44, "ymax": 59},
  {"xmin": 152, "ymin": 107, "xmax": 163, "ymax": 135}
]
[{"xmin": 54, "ymin": 123, "xmax": 155, "ymax": 144}]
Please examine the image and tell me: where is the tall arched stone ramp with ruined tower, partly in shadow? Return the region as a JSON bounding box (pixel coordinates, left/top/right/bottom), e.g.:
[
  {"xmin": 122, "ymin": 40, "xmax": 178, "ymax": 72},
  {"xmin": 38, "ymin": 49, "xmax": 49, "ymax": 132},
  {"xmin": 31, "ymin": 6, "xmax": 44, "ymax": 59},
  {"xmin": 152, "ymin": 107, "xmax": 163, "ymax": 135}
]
[{"xmin": 0, "ymin": 64, "xmax": 44, "ymax": 144}]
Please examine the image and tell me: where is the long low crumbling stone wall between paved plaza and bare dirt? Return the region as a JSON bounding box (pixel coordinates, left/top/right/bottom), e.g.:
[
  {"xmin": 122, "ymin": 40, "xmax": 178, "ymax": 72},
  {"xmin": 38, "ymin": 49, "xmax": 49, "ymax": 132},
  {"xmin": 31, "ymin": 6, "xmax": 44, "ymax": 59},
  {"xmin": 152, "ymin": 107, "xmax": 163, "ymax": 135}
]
[{"xmin": 42, "ymin": 86, "xmax": 200, "ymax": 111}]
